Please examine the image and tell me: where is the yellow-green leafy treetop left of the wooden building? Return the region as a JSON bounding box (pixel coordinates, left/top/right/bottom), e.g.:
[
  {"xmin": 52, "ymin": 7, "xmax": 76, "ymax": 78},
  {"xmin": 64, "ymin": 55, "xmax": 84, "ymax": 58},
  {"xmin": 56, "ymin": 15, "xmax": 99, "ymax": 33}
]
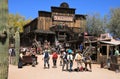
[{"xmin": 8, "ymin": 14, "xmax": 31, "ymax": 32}]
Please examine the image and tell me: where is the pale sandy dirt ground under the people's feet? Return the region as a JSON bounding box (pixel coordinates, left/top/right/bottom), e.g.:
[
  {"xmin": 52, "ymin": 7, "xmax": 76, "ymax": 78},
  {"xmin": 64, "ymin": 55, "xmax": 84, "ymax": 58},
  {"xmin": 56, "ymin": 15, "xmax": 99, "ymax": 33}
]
[{"xmin": 8, "ymin": 55, "xmax": 120, "ymax": 79}]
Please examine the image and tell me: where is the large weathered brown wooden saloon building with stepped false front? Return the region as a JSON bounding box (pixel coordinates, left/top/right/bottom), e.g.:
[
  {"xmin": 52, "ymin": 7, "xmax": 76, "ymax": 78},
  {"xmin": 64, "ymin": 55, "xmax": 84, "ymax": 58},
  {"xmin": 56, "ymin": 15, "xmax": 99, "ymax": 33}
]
[{"xmin": 21, "ymin": 2, "xmax": 86, "ymax": 48}]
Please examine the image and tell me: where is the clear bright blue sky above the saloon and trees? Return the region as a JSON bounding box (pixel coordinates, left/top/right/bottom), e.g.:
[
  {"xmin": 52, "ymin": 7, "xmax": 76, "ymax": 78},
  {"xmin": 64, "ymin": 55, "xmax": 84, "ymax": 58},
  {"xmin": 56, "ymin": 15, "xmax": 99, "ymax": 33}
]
[{"xmin": 8, "ymin": 0, "xmax": 120, "ymax": 19}]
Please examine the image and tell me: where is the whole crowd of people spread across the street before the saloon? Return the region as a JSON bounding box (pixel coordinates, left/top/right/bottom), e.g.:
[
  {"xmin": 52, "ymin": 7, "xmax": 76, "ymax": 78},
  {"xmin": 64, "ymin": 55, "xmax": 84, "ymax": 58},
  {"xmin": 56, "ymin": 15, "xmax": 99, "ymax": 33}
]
[{"xmin": 9, "ymin": 41, "xmax": 119, "ymax": 72}]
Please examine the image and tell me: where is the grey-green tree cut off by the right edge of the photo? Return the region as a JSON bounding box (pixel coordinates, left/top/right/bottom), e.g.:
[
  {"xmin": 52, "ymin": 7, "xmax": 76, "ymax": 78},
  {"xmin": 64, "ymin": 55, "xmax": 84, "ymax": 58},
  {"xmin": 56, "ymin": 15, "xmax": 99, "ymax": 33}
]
[{"xmin": 108, "ymin": 8, "xmax": 120, "ymax": 38}]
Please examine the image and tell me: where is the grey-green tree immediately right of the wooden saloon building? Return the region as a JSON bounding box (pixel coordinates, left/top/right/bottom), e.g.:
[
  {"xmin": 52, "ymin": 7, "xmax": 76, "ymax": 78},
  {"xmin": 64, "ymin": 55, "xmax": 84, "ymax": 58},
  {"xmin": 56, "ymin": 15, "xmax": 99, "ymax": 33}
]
[{"xmin": 87, "ymin": 14, "xmax": 106, "ymax": 36}]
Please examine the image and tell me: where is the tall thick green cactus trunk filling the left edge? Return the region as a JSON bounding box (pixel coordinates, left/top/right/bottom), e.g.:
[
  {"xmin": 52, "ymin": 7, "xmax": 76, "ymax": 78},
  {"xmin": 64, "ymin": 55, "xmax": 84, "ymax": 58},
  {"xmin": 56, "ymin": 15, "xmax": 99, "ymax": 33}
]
[{"xmin": 0, "ymin": 0, "xmax": 9, "ymax": 79}]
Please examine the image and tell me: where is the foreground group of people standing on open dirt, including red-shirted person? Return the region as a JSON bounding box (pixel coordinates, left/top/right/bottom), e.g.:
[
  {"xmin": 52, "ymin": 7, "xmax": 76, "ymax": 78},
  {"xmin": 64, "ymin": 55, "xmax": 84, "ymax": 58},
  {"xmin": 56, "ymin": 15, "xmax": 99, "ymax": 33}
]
[{"xmin": 43, "ymin": 48, "xmax": 92, "ymax": 72}]
